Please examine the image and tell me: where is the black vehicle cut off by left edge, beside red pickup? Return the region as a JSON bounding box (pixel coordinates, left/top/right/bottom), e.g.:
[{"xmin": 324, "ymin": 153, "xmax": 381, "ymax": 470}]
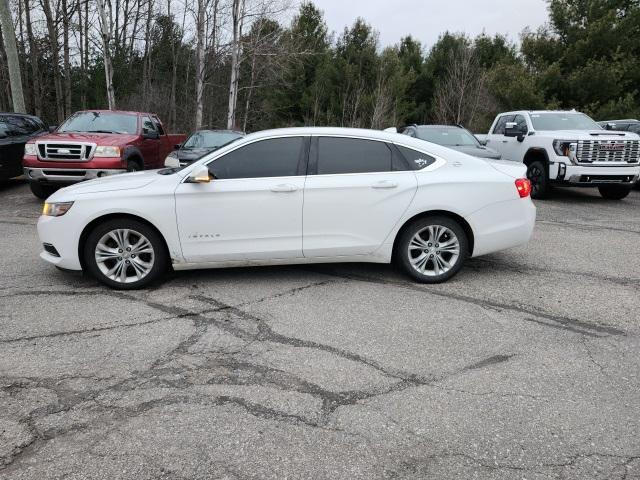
[{"xmin": 0, "ymin": 113, "xmax": 47, "ymax": 180}]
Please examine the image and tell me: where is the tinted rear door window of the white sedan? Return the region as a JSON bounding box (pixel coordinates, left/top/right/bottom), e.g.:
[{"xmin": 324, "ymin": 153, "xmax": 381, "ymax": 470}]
[{"xmin": 318, "ymin": 137, "xmax": 392, "ymax": 175}]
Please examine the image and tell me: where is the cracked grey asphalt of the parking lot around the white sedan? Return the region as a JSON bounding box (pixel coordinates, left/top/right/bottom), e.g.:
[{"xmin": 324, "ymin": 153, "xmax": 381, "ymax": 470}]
[{"xmin": 0, "ymin": 181, "xmax": 640, "ymax": 480}]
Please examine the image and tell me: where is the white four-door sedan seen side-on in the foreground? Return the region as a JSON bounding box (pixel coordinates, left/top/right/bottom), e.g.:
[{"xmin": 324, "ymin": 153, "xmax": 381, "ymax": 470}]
[{"xmin": 38, "ymin": 128, "xmax": 536, "ymax": 289}]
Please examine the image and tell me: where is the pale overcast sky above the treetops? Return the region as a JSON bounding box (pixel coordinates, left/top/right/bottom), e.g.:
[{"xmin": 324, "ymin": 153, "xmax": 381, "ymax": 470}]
[{"xmin": 313, "ymin": 0, "xmax": 547, "ymax": 48}]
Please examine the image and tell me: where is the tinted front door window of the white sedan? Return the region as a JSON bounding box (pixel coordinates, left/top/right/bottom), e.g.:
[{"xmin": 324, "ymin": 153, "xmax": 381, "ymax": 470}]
[{"xmin": 208, "ymin": 137, "xmax": 304, "ymax": 180}]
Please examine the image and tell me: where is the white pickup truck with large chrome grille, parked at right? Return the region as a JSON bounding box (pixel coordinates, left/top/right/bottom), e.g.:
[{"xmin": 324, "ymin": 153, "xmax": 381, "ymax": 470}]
[{"xmin": 486, "ymin": 110, "xmax": 640, "ymax": 200}]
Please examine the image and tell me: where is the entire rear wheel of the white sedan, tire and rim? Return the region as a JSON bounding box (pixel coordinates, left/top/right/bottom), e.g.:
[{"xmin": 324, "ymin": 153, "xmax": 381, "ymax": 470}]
[{"xmin": 396, "ymin": 216, "xmax": 469, "ymax": 283}]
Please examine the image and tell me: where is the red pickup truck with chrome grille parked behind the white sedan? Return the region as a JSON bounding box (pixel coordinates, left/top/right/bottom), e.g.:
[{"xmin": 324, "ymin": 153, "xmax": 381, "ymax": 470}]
[{"xmin": 22, "ymin": 110, "xmax": 186, "ymax": 199}]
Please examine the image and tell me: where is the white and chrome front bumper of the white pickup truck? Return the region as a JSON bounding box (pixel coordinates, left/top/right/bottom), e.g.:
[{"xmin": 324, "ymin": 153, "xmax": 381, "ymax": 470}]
[{"xmin": 549, "ymin": 162, "xmax": 640, "ymax": 187}]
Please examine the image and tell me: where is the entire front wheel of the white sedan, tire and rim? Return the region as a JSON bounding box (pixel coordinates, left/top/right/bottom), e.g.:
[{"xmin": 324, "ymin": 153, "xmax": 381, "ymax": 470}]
[{"xmin": 84, "ymin": 218, "xmax": 167, "ymax": 290}]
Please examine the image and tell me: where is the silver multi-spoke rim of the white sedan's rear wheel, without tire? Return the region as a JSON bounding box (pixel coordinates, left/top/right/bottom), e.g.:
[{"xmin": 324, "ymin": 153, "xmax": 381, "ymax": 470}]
[{"xmin": 407, "ymin": 225, "xmax": 460, "ymax": 277}]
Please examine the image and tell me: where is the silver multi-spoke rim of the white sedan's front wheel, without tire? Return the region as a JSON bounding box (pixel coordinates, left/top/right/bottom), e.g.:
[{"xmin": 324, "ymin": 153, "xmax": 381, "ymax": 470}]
[{"xmin": 94, "ymin": 228, "xmax": 155, "ymax": 283}]
